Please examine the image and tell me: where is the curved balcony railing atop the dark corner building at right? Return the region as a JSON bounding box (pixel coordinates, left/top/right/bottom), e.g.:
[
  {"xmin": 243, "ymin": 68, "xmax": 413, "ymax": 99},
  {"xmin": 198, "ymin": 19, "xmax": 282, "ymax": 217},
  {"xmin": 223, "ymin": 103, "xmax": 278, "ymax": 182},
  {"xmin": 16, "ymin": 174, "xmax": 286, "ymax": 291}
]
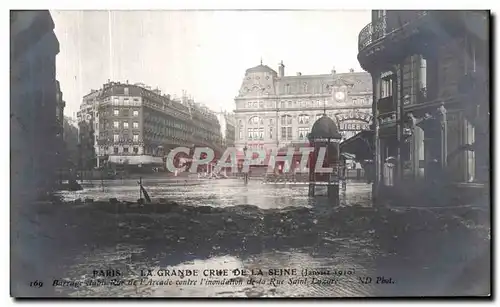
[{"xmin": 358, "ymin": 11, "xmax": 428, "ymax": 52}]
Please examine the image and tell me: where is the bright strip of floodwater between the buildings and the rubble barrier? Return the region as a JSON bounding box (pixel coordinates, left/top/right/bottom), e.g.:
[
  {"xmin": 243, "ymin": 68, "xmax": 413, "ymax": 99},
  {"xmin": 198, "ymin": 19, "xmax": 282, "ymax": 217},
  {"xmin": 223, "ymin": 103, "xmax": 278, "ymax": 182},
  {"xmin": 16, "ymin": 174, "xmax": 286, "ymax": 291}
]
[{"xmin": 59, "ymin": 179, "xmax": 371, "ymax": 209}]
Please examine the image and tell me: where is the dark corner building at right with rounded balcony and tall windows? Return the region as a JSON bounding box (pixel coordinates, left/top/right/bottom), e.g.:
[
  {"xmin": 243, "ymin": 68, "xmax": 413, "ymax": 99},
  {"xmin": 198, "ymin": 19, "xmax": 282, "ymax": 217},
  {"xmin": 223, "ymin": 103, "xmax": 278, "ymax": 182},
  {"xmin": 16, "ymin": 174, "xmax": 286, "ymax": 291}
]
[{"xmin": 358, "ymin": 11, "xmax": 490, "ymax": 197}]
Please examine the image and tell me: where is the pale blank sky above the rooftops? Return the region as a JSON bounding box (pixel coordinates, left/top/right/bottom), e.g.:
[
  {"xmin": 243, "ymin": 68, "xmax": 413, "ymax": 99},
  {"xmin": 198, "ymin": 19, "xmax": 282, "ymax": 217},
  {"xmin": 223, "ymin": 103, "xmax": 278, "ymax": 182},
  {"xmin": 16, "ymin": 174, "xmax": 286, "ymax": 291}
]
[{"xmin": 51, "ymin": 10, "xmax": 371, "ymax": 116}]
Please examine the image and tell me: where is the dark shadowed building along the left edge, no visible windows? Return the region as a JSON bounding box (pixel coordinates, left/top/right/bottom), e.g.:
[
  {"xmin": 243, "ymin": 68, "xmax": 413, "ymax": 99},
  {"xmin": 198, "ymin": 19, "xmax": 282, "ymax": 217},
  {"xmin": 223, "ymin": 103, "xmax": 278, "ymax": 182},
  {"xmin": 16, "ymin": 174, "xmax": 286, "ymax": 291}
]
[{"xmin": 10, "ymin": 11, "xmax": 62, "ymax": 202}]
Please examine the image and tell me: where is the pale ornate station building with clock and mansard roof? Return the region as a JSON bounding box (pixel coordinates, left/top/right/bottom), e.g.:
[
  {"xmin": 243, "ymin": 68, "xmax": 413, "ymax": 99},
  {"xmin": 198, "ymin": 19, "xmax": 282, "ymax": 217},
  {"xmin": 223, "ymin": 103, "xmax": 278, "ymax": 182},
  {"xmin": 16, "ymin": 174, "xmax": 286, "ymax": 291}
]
[{"xmin": 235, "ymin": 62, "xmax": 372, "ymax": 153}]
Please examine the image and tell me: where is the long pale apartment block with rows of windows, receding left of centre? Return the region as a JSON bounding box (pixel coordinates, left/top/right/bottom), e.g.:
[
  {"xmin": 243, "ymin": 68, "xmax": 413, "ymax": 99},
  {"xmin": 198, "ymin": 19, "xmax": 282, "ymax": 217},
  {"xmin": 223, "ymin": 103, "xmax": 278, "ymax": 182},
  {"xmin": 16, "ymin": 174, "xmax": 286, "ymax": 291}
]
[{"xmin": 77, "ymin": 81, "xmax": 222, "ymax": 171}]
